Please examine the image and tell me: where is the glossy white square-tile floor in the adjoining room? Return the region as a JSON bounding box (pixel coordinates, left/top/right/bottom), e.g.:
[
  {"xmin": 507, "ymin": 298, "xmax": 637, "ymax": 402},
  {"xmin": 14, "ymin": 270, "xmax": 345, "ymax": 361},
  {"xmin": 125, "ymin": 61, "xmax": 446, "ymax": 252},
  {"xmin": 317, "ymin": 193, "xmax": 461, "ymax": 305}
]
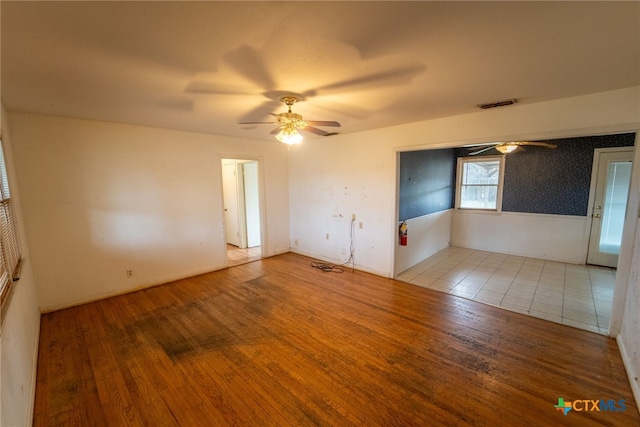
[{"xmin": 397, "ymin": 246, "xmax": 615, "ymax": 335}]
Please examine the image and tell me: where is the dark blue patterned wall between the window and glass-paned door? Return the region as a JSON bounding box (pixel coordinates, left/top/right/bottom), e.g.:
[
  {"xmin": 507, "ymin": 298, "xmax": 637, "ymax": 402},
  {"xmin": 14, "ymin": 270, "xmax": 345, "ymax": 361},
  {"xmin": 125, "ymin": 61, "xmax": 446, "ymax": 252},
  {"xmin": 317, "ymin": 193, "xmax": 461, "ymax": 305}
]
[{"xmin": 504, "ymin": 133, "xmax": 635, "ymax": 216}]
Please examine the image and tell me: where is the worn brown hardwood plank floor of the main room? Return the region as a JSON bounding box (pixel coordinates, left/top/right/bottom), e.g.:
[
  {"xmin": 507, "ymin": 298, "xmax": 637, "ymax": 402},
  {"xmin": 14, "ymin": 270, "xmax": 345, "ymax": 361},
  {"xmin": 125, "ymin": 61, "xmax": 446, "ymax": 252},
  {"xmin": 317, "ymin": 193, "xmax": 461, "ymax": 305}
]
[{"xmin": 34, "ymin": 254, "xmax": 640, "ymax": 426}]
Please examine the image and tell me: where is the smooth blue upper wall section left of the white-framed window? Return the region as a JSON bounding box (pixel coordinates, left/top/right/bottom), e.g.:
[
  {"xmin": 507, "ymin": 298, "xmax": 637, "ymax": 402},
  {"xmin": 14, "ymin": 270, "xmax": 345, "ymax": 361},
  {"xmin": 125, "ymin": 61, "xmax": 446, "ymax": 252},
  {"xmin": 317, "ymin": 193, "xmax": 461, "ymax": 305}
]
[{"xmin": 399, "ymin": 149, "xmax": 456, "ymax": 221}]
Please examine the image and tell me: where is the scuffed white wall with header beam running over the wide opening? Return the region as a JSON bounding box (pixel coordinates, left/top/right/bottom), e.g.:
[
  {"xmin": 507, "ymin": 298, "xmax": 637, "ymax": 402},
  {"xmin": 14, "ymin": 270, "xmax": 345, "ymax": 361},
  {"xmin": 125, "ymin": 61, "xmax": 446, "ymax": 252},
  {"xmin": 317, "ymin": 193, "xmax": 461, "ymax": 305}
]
[{"xmin": 289, "ymin": 87, "xmax": 640, "ymax": 276}]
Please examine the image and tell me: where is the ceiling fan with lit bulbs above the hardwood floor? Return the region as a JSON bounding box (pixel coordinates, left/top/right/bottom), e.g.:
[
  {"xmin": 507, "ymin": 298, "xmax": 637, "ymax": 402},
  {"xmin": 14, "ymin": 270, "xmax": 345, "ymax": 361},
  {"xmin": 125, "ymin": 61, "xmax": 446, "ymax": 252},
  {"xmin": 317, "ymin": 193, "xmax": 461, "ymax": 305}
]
[{"xmin": 239, "ymin": 95, "xmax": 340, "ymax": 145}]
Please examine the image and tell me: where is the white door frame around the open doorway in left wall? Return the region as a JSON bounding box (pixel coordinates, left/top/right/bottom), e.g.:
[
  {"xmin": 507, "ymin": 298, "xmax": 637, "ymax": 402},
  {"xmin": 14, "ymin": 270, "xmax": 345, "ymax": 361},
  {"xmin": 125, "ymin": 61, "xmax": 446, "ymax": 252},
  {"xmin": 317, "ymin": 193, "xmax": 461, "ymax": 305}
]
[{"xmin": 217, "ymin": 154, "xmax": 268, "ymax": 267}]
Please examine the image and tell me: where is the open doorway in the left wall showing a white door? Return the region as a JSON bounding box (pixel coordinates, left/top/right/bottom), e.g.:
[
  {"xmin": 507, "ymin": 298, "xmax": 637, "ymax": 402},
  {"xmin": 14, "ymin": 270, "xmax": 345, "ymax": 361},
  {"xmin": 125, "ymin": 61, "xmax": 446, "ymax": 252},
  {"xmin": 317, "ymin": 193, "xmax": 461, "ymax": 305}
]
[{"xmin": 221, "ymin": 159, "xmax": 262, "ymax": 267}]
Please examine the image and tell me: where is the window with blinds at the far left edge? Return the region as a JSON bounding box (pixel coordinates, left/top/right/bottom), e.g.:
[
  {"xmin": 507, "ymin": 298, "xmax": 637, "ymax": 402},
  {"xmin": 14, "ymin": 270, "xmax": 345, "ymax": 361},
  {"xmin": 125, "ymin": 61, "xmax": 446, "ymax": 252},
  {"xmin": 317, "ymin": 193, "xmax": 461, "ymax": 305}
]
[{"xmin": 0, "ymin": 141, "xmax": 20, "ymax": 305}]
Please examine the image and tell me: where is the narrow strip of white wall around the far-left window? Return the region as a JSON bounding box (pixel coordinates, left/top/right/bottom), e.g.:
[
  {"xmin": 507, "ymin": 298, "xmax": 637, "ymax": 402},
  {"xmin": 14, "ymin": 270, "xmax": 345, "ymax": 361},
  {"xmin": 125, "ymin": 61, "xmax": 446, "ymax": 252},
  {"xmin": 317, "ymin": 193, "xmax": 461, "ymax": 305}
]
[{"xmin": 0, "ymin": 108, "xmax": 40, "ymax": 427}]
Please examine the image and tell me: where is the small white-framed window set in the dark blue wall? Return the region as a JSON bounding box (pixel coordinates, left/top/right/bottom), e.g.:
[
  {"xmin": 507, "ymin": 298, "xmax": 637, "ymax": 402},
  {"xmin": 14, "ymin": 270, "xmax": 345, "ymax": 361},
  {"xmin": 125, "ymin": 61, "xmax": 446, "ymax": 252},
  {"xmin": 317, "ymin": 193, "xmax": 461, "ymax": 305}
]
[{"xmin": 456, "ymin": 156, "xmax": 504, "ymax": 212}]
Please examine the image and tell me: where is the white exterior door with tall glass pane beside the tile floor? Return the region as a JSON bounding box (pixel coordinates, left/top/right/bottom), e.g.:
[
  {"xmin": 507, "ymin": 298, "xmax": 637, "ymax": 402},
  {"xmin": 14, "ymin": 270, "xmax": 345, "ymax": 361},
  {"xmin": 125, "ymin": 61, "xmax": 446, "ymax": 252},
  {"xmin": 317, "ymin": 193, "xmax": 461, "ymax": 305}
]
[{"xmin": 587, "ymin": 149, "xmax": 633, "ymax": 268}]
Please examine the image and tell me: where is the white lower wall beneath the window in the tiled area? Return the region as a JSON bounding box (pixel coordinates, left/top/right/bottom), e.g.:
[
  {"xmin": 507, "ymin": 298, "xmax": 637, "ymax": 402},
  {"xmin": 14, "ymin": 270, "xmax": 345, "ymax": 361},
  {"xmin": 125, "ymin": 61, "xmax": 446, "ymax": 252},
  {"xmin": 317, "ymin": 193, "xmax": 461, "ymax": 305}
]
[{"xmin": 451, "ymin": 210, "xmax": 591, "ymax": 264}]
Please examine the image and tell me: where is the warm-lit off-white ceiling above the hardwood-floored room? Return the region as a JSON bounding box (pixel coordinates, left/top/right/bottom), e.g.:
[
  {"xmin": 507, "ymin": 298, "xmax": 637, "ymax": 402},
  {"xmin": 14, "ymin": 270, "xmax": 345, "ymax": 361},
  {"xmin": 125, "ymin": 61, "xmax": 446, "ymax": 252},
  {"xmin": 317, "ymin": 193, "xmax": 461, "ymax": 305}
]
[{"xmin": 1, "ymin": 1, "xmax": 640, "ymax": 139}]
